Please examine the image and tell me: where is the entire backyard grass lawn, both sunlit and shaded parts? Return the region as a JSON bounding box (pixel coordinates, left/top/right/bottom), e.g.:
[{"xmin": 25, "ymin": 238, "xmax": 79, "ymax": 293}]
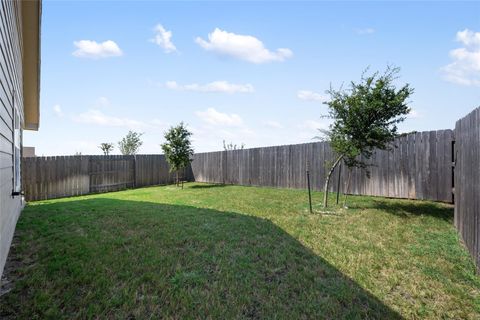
[{"xmin": 0, "ymin": 184, "xmax": 480, "ymax": 319}]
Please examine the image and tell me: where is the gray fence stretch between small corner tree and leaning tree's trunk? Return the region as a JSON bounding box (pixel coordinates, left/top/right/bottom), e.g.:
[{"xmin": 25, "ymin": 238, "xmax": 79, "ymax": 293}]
[{"xmin": 192, "ymin": 142, "xmax": 337, "ymax": 190}]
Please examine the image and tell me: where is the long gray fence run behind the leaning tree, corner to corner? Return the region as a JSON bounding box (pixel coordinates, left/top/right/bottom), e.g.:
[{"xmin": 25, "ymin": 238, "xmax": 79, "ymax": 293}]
[{"xmin": 192, "ymin": 130, "xmax": 453, "ymax": 202}]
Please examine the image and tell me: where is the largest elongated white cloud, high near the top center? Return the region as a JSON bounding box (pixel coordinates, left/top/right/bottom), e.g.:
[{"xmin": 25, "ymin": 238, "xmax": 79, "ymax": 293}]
[{"xmin": 195, "ymin": 28, "xmax": 293, "ymax": 63}]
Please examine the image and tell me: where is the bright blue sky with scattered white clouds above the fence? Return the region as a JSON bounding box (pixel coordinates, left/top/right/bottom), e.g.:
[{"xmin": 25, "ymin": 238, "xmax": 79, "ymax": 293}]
[{"xmin": 24, "ymin": 0, "xmax": 480, "ymax": 155}]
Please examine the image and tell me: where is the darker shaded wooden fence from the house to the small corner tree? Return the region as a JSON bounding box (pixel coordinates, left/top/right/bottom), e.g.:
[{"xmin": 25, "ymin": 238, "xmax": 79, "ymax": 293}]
[{"xmin": 22, "ymin": 155, "xmax": 193, "ymax": 201}]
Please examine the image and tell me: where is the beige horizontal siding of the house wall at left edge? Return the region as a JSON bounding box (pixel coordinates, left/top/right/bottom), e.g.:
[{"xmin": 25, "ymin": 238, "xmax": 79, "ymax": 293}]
[{"xmin": 0, "ymin": 0, "xmax": 23, "ymax": 274}]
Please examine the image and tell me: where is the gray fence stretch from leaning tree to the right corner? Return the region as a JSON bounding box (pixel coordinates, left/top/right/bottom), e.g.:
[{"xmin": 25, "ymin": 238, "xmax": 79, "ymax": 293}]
[{"xmin": 349, "ymin": 130, "xmax": 453, "ymax": 202}]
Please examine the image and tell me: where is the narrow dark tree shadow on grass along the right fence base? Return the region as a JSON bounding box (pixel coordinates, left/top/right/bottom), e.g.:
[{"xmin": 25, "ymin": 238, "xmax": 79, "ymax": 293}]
[{"xmin": 352, "ymin": 199, "xmax": 454, "ymax": 222}]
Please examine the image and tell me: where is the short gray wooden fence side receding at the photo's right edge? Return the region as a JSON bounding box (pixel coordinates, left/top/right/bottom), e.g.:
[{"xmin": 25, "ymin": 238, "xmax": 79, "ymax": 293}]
[{"xmin": 455, "ymin": 108, "xmax": 480, "ymax": 271}]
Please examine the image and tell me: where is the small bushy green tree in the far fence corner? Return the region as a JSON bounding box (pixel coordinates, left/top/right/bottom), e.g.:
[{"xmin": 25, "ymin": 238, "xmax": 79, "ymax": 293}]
[{"xmin": 161, "ymin": 122, "xmax": 193, "ymax": 186}]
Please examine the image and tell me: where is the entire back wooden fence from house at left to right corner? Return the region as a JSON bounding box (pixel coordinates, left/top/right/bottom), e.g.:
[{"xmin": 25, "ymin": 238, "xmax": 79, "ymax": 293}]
[{"xmin": 22, "ymin": 130, "xmax": 453, "ymax": 202}]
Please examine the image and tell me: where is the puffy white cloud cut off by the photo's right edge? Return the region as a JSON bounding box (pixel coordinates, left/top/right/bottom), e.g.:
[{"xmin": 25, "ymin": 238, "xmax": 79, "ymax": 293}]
[{"xmin": 442, "ymin": 29, "xmax": 480, "ymax": 86}]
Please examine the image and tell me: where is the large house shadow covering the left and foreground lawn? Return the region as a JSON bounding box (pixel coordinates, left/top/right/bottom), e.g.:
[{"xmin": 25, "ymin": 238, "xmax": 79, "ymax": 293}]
[{"xmin": 0, "ymin": 198, "xmax": 401, "ymax": 319}]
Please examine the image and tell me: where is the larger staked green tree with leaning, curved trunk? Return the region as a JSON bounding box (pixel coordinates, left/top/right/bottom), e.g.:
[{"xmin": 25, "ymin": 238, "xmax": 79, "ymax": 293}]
[{"xmin": 323, "ymin": 67, "xmax": 413, "ymax": 208}]
